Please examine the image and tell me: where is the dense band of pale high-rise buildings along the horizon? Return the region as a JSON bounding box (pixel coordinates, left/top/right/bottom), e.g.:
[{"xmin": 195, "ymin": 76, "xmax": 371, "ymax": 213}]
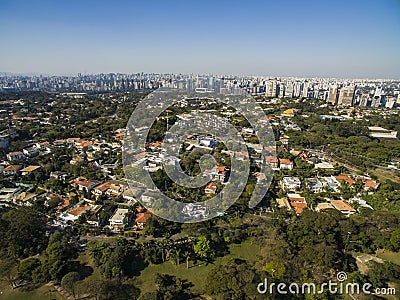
[{"xmin": 0, "ymin": 73, "xmax": 400, "ymax": 108}]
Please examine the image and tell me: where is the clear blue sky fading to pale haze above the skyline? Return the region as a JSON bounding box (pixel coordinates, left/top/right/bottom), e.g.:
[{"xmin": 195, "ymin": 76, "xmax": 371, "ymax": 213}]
[{"xmin": 0, "ymin": 0, "xmax": 400, "ymax": 78}]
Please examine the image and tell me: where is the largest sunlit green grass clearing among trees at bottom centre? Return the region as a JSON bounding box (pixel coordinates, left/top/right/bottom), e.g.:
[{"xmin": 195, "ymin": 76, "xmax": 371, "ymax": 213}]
[{"xmin": 134, "ymin": 241, "xmax": 260, "ymax": 293}]
